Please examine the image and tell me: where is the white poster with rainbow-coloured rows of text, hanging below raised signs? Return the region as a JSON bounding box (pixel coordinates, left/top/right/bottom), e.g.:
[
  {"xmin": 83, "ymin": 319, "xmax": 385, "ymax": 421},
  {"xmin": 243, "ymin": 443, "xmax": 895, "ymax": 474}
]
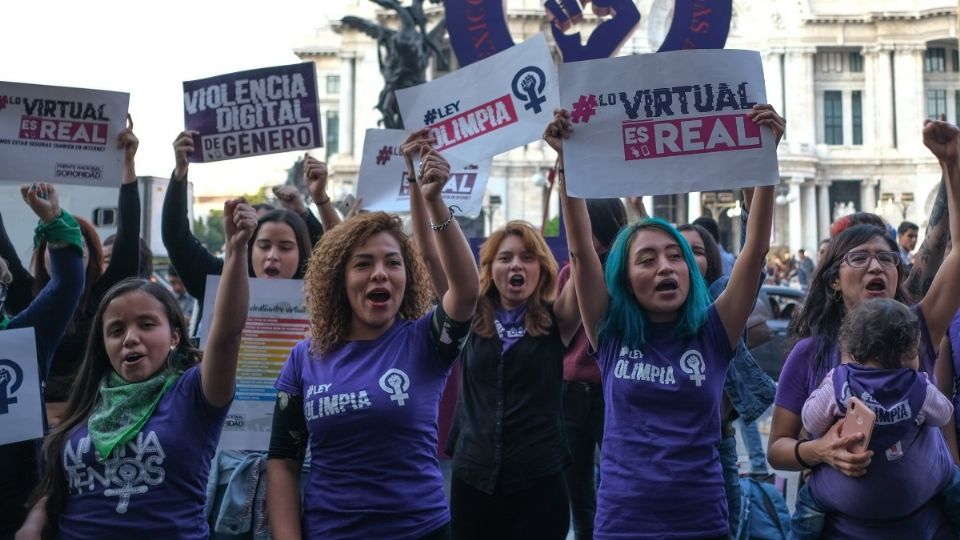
[{"xmin": 198, "ymin": 276, "xmax": 310, "ymax": 450}]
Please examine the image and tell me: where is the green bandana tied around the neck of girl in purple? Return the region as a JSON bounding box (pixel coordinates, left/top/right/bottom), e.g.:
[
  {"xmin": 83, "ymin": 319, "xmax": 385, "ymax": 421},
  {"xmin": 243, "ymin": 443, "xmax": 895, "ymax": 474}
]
[{"xmin": 87, "ymin": 369, "xmax": 180, "ymax": 461}]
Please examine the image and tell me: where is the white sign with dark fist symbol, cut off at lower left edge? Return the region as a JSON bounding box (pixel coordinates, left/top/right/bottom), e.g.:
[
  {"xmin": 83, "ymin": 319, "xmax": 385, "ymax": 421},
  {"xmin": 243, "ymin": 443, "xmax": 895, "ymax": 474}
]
[{"xmin": 0, "ymin": 328, "xmax": 44, "ymax": 444}]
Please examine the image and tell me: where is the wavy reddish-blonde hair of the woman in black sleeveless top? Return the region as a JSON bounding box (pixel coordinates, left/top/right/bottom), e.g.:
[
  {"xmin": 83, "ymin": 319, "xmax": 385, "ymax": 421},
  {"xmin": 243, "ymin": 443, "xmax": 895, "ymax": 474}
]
[{"xmin": 473, "ymin": 221, "xmax": 557, "ymax": 338}]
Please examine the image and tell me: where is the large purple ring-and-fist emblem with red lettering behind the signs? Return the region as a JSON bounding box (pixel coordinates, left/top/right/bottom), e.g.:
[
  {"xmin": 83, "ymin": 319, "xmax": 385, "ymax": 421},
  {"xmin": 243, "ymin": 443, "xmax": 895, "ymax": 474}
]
[{"xmin": 443, "ymin": 0, "xmax": 733, "ymax": 66}]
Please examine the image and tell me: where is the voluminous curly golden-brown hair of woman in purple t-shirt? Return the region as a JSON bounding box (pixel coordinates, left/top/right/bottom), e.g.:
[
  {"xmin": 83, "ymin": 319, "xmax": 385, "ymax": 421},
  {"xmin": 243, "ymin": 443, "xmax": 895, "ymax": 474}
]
[{"xmin": 304, "ymin": 212, "xmax": 433, "ymax": 353}]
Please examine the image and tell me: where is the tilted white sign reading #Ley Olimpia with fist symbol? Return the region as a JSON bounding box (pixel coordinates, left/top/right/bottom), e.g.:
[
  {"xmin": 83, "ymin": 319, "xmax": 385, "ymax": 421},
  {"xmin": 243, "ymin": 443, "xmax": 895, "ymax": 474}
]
[{"xmin": 397, "ymin": 34, "xmax": 559, "ymax": 164}]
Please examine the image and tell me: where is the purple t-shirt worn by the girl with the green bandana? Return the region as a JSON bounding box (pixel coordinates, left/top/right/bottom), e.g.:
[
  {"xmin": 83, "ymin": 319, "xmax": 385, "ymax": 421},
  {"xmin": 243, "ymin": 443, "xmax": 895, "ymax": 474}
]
[{"xmin": 59, "ymin": 366, "xmax": 229, "ymax": 540}]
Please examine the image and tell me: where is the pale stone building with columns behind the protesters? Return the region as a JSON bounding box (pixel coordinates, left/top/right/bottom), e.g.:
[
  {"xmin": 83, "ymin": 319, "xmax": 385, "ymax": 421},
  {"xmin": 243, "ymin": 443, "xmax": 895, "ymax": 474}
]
[{"xmin": 295, "ymin": 0, "xmax": 960, "ymax": 252}]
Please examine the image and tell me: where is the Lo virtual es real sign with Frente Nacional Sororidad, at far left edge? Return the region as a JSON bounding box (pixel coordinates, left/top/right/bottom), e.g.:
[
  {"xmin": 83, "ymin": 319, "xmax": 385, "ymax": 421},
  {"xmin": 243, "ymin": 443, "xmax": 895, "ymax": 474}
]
[{"xmin": 0, "ymin": 82, "xmax": 130, "ymax": 187}]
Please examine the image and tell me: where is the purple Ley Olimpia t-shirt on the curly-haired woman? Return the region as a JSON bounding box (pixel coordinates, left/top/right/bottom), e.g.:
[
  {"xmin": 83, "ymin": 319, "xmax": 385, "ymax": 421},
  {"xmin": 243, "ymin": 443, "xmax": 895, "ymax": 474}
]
[{"xmin": 276, "ymin": 312, "xmax": 450, "ymax": 540}]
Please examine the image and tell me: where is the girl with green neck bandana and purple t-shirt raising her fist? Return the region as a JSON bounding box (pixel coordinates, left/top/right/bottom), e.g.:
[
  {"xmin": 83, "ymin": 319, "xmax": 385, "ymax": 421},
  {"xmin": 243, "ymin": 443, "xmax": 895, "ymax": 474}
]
[{"xmin": 18, "ymin": 200, "xmax": 256, "ymax": 539}]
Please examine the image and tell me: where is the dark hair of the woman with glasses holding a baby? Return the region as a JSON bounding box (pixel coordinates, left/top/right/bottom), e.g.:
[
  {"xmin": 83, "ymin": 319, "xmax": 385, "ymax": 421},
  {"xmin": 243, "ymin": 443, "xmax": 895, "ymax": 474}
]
[{"xmin": 790, "ymin": 224, "xmax": 907, "ymax": 374}]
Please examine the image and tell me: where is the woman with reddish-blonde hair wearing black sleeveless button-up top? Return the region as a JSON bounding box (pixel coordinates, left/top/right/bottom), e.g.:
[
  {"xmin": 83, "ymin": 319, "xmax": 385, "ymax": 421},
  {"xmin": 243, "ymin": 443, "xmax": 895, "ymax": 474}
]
[{"xmin": 448, "ymin": 217, "xmax": 580, "ymax": 539}]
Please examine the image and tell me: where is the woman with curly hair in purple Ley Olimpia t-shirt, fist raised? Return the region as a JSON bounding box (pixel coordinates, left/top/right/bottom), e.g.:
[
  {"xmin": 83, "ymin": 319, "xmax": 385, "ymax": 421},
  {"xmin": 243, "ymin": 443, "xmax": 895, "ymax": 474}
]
[{"xmin": 267, "ymin": 147, "xmax": 479, "ymax": 540}]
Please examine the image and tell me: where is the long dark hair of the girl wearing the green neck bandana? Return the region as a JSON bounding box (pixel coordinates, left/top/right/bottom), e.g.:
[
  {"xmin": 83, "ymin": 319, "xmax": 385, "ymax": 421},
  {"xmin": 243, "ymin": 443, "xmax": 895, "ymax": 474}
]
[{"xmin": 32, "ymin": 278, "xmax": 202, "ymax": 524}]
